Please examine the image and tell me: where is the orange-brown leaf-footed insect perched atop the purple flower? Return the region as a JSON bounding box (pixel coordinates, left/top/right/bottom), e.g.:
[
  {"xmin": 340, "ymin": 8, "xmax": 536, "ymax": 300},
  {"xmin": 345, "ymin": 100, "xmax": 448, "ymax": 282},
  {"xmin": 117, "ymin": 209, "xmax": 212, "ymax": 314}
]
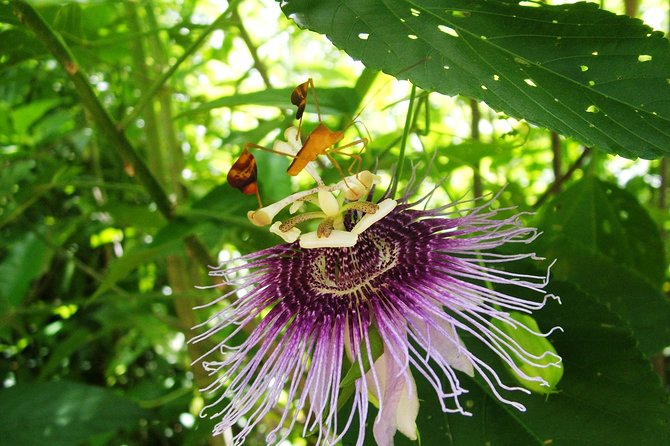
[{"xmin": 227, "ymin": 78, "xmax": 368, "ymax": 207}]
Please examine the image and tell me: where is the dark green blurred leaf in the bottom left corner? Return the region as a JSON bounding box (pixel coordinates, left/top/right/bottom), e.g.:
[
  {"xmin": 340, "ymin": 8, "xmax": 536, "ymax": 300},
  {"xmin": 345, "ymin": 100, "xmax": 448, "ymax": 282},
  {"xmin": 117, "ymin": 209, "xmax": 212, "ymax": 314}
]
[{"xmin": 0, "ymin": 381, "xmax": 143, "ymax": 446}]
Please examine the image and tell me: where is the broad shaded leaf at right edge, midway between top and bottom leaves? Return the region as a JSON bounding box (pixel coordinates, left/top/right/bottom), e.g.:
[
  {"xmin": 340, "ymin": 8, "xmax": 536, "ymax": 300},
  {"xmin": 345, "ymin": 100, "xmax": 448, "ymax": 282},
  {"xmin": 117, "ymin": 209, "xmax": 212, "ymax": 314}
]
[{"xmin": 536, "ymin": 178, "xmax": 670, "ymax": 355}]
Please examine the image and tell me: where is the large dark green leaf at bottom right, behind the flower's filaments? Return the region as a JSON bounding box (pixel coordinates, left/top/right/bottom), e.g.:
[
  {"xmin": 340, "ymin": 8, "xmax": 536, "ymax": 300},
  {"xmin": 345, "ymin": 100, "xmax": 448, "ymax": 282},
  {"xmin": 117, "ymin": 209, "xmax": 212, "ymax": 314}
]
[{"xmin": 344, "ymin": 282, "xmax": 670, "ymax": 446}]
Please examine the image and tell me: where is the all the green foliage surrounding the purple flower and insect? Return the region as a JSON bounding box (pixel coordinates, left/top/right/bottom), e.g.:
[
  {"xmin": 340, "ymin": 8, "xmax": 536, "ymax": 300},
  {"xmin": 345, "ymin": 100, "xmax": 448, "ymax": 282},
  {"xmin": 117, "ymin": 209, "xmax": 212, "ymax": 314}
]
[{"xmin": 0, "ymin": 0, "xmax": 670, "ymax": 445}]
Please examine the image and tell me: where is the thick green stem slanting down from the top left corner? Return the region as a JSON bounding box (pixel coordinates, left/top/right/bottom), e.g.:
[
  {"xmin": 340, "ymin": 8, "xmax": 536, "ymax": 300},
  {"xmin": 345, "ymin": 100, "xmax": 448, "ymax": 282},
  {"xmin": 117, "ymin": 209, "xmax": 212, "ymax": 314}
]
[{"xmin": 11, "ymin": 0, "xmax": 173, "ymax": 218}]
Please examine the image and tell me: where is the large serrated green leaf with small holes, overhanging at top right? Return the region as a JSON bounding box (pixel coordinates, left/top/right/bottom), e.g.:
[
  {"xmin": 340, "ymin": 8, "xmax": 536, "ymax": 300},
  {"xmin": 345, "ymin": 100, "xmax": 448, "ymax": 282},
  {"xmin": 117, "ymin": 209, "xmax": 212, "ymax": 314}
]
[{"xmin": 282, "ymin": 0, "xmax": 670, "ymax": 158}]
